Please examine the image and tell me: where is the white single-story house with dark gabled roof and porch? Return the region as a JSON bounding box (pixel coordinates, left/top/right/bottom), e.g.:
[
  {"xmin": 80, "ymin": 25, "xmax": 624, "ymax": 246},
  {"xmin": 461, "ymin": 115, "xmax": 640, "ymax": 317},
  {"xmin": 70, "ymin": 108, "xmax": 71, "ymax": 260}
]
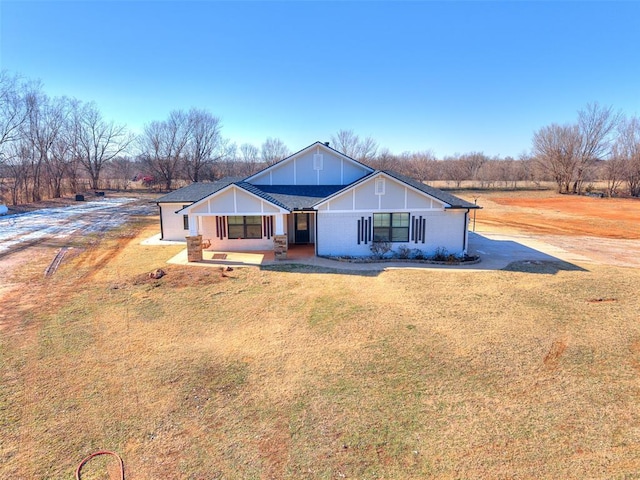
[{"xmin": 157, "ymin": 142, "xmax": 478, "ymax": 256}]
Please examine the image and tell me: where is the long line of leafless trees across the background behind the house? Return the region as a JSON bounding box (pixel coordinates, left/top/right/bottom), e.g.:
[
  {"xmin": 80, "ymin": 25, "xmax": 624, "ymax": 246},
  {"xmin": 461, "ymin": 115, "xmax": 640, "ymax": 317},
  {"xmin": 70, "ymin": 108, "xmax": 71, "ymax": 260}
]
[{"xmin": 0, "ymin": 71, "xmax": 640, "ymax": 205}]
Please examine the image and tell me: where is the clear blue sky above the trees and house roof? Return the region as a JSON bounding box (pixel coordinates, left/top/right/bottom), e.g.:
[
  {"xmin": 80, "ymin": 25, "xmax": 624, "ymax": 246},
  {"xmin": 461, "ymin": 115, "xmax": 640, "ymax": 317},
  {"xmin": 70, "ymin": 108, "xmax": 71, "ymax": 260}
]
[{"xmin": 0, "ymin": 0, "xmax": 640, "ymax": 156}]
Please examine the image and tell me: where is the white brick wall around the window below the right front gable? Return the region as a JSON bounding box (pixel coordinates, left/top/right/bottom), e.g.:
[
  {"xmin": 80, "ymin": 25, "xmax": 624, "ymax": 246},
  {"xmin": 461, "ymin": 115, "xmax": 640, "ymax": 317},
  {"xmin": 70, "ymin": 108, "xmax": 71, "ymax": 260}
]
[{"xmin": 316, "ymin": 210, "xmax": 466, "ymax": 257}]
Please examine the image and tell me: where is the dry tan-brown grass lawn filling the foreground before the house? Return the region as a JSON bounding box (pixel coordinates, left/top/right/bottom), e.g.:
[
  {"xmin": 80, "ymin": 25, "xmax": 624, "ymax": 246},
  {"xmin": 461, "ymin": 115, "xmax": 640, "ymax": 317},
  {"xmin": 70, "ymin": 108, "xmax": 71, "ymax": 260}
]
[{"xmin": 0, "ymin": 193, "xmax": 640, "ymax": 480}]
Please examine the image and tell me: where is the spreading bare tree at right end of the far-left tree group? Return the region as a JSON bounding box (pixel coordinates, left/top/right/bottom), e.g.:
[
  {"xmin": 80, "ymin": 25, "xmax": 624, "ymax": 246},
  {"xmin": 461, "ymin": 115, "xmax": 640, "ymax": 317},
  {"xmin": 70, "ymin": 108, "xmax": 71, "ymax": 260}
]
[{"xmin": 74, "ymin": 102, "xmax": 134, "ymax": 189}]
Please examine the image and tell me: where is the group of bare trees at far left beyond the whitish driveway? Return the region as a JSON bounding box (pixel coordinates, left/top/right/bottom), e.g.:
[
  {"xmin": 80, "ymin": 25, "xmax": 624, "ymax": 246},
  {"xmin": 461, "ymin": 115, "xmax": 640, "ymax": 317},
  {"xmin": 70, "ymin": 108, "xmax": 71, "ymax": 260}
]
[{"xmin": 0, "ymin": 71, "xmax": 134, "ymax": 204}]
